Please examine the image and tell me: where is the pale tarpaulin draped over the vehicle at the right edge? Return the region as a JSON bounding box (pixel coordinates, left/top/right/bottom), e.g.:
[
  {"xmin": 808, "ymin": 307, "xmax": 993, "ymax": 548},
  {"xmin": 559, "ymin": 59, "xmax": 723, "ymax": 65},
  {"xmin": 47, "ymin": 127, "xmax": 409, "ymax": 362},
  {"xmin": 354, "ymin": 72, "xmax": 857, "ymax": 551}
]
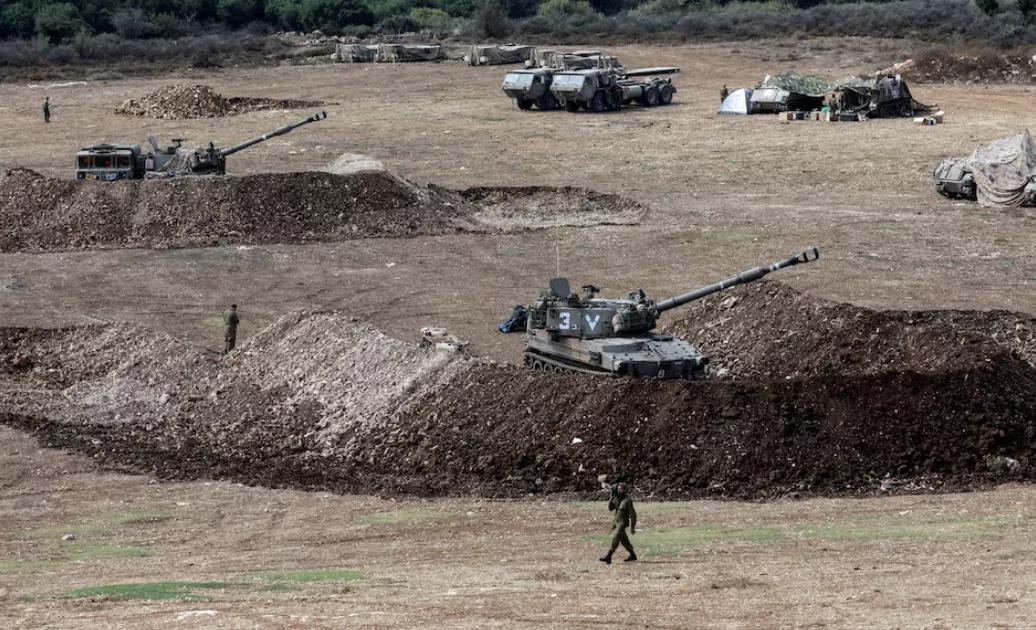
[{"xmin": 966, "ymin": 132, "xmax": 1036, "ymax": 205}]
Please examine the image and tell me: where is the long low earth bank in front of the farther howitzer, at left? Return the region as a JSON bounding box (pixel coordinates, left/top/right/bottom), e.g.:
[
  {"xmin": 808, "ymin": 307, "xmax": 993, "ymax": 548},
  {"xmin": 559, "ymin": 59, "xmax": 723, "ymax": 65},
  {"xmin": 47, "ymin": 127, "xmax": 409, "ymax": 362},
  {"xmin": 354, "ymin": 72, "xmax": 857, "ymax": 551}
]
[{"xmin": 0, "ymin": 169, "xmax": 644, "ymax": 252}]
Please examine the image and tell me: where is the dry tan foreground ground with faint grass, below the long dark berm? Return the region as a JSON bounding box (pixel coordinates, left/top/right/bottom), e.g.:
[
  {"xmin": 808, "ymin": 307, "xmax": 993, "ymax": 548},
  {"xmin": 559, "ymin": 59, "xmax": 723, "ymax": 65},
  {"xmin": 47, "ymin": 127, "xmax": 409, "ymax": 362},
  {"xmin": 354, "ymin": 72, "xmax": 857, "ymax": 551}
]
[{"xmin": 6, "ymin": 428, "xmax": 1036, "ymax": 628}]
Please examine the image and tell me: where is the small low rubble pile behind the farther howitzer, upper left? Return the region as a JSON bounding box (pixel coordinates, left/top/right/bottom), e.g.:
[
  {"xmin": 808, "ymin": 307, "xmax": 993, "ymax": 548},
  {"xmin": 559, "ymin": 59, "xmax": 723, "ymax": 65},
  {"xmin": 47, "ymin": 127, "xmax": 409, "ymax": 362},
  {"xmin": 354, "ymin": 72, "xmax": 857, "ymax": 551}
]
[{"xmin": 115, "ymin": 84, "xmax": 324, "ymax": 120}]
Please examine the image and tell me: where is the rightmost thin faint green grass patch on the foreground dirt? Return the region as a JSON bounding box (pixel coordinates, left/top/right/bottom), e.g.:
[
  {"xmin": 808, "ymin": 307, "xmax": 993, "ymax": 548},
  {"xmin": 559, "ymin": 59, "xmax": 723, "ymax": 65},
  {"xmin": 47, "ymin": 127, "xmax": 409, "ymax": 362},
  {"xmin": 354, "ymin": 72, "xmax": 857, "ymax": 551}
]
[{"xmin": 795, "ymin": 517, "xmax": 1011, "ymax": 542}]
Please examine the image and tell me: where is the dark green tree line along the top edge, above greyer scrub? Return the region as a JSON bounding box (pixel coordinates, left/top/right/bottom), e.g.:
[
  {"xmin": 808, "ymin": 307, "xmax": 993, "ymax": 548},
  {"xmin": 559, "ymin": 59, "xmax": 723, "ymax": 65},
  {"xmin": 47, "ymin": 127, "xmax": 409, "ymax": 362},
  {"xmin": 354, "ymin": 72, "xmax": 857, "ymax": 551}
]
[{"xmin": 0, "ymin": 0, "xmax": 1036, "ymax": 44}]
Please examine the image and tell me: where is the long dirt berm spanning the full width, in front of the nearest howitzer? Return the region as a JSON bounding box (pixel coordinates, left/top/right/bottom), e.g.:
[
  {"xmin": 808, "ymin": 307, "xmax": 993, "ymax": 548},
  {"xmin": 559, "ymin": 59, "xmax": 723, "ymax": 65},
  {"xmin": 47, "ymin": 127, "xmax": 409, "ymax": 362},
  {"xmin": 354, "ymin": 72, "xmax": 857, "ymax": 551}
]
[{"xmin": 0, "ymin": 283, "xmax": 1036, "ymax": 498}]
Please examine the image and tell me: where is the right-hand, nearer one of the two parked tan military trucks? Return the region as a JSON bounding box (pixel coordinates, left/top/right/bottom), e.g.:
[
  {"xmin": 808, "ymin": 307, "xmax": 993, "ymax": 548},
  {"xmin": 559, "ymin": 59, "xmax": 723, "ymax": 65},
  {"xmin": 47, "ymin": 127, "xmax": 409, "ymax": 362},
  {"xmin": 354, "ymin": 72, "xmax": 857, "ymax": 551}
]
[{"xmin": 550, "ymin": 66, "xmax": 680, "ymax": 112}]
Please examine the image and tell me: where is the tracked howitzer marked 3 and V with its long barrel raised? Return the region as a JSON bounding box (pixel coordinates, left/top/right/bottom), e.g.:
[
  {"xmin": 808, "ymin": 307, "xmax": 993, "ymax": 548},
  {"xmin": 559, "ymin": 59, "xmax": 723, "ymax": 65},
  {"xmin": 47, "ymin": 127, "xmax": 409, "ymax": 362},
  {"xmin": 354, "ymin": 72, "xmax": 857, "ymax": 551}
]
[{"xmin": 524, "ymin": 247, "xmax": 821, "ymax": 379}]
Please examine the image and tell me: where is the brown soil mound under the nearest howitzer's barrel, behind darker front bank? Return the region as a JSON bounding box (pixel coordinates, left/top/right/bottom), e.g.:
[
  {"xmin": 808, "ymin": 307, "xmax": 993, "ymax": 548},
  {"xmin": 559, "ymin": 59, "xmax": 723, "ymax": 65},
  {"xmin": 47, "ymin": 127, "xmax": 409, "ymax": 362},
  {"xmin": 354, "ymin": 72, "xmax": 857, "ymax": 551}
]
[{"xmin": 665, "ymin": 282, "xmax": 1036, "ymax": 379}]
